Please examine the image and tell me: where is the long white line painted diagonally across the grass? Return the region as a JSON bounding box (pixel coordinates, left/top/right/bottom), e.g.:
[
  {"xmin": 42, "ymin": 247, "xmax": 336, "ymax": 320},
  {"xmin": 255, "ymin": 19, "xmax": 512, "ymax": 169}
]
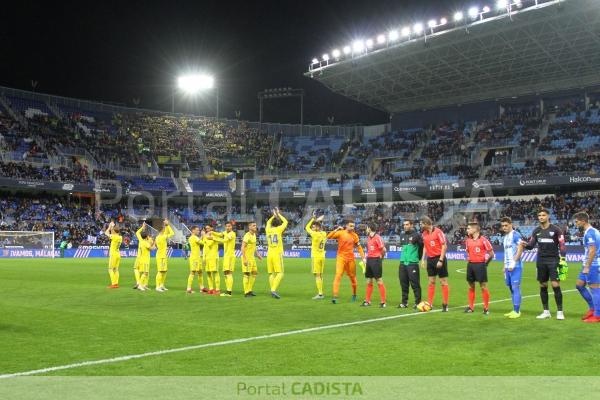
[{"xmin": 0, "ymin": 289, "xmax": 576, "ymax": 379}]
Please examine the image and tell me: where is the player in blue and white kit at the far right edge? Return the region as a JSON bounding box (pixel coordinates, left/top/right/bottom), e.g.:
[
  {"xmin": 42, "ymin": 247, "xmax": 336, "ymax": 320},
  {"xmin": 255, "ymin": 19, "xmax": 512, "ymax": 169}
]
[{"xmin": 574, "ymin": 212, "xmax": 600, "ymax": 322}]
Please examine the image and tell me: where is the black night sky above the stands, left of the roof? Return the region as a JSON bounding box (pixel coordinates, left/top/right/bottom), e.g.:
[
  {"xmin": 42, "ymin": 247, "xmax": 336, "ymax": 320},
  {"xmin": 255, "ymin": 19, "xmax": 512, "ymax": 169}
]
[{"xmin": 0, "ymin": 0, "xmax": 462, "ymax": 124}]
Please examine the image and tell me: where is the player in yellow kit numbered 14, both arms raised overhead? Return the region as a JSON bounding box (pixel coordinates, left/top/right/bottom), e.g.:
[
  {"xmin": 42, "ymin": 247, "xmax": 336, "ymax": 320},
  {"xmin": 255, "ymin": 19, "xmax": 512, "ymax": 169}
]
[{"xmin": 265, "ymin": 208, "xmax": 288, "ymax": 299}]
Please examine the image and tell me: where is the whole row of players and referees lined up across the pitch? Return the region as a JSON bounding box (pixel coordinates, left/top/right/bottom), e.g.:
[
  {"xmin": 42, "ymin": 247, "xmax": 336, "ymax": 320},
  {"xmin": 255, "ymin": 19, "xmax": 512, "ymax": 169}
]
[{"xmin": 104, "ymin": 208, "xmax": 600, "ymax": 323}]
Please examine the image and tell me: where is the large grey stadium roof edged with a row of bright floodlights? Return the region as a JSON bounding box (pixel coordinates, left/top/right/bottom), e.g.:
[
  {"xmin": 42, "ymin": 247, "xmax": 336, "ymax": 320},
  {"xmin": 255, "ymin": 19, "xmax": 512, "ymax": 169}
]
[{"xmin": 305, "ymin": 0, "xmax": 600, "ymax": 113}]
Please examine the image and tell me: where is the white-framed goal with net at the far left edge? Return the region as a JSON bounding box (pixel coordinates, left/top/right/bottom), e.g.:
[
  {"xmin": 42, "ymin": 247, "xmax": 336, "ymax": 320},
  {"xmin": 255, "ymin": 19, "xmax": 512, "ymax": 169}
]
[{"xmin": 0, "ymin": 231, "xmax": 54, "ymax": 258}]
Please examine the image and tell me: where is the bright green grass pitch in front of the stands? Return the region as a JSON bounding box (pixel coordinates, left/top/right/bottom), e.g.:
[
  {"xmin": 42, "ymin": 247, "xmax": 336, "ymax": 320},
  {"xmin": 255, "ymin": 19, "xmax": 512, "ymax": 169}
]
[{"xmin": 0, "ymin": 259, "xmax": 600, "ymax": 376}]
